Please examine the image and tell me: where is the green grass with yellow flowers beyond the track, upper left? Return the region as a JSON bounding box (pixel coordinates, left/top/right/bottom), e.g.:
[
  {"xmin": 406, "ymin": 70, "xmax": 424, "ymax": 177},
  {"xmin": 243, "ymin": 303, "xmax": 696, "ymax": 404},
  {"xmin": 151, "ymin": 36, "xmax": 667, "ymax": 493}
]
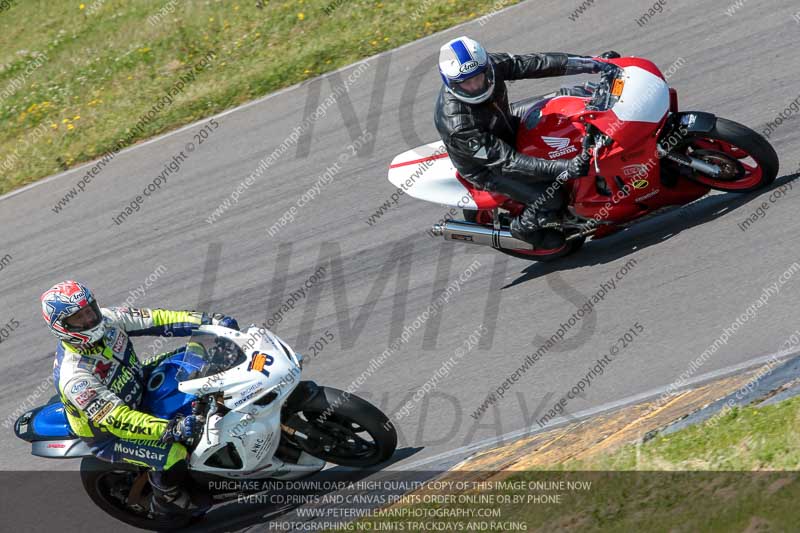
[{"xmin": 0, "ymin": 0, "xmax": 515, "ymax": 193}]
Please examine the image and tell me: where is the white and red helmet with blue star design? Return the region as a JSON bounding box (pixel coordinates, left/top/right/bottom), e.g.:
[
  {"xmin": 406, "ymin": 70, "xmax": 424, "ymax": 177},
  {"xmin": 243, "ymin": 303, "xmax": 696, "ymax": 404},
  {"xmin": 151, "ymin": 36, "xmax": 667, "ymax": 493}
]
[{"xmin": 41, "ymin": 280, "xmax": 105, "ymax": 346}]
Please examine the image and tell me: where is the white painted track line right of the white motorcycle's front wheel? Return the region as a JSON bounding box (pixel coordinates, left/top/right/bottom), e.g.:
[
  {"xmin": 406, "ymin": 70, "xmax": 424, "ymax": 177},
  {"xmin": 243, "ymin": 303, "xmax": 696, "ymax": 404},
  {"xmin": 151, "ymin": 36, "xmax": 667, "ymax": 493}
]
[{"xmin": 396, "ymin": 350, "xmax": 800, "ymax": 471}]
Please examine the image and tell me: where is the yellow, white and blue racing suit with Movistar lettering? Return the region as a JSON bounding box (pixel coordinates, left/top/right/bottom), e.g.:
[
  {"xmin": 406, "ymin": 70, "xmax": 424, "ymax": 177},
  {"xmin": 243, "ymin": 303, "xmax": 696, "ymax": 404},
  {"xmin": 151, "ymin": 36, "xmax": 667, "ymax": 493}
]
[{"xmin": 53, "ymin": 307, "xmax": 217, "ymax": 470}]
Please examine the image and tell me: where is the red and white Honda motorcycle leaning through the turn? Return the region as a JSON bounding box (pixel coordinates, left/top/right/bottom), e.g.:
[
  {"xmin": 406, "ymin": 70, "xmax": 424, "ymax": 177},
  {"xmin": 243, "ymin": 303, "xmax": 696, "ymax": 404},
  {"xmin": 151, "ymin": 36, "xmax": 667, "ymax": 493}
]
[{"xmin": 389, "ymin": 57, "xmax": 778, "ymax": 261}]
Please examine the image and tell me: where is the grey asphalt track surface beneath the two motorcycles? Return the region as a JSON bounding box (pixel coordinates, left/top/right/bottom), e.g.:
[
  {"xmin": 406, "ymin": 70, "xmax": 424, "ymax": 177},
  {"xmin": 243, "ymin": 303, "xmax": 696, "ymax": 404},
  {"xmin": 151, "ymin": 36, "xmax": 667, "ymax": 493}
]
[{"xmin": 0, "ymin": 0, "xmax": 800, "ymax": 528}]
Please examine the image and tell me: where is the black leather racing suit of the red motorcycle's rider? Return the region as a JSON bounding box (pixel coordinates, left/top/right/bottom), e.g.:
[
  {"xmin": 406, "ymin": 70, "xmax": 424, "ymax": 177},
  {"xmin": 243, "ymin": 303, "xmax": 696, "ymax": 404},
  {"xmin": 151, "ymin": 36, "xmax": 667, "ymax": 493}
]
[{"xmin": 434, "ymin": 53, "xmax": 579, "ymax": 243}]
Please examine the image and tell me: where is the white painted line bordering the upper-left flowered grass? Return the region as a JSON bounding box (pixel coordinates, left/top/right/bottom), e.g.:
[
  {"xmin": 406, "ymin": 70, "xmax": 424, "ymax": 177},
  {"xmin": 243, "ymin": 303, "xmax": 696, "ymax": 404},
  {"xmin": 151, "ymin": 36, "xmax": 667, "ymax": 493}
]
[{"xmin": 0, "ymin": 1, "xmax": 536, "ymax": 201}]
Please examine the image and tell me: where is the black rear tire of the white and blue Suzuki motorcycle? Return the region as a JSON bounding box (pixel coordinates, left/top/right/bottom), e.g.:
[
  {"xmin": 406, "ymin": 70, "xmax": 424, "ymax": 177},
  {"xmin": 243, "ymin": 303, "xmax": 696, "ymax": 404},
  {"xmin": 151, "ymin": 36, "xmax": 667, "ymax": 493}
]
[{"xmin": 81, "ymin": 457, "xmax": 195, "ymax": 531}]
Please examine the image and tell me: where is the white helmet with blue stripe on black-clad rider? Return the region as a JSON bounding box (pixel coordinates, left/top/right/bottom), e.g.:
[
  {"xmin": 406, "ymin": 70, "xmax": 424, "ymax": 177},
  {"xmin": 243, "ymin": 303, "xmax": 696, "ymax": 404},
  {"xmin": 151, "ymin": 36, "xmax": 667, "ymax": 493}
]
[{"xmin": 439, "ymin": 36, "xmax": 494, "ymax": 104}]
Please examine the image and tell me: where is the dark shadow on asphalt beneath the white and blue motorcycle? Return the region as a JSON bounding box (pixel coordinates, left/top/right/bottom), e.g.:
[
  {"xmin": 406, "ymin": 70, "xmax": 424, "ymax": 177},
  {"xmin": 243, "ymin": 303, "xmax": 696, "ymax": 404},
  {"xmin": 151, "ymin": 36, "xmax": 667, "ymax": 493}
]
[{"xmin": 189, "ymin": 447, "xmax": 424, "ymax": 533}]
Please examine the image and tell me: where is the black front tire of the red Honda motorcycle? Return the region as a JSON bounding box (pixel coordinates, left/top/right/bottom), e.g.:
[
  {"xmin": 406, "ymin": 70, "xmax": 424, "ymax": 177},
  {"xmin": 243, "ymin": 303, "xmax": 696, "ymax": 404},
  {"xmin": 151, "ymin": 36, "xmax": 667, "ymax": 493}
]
[{"xmin": 687, "ymin": 118, "xmax": 779, "ymax": 193}]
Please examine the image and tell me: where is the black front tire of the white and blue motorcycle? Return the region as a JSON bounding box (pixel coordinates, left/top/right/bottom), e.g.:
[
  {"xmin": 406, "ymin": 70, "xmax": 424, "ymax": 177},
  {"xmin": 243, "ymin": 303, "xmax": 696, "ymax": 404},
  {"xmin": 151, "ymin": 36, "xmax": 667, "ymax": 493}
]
[{"xmin": 286, "ymin": 387, "xmax": 397, "ymax": 468}]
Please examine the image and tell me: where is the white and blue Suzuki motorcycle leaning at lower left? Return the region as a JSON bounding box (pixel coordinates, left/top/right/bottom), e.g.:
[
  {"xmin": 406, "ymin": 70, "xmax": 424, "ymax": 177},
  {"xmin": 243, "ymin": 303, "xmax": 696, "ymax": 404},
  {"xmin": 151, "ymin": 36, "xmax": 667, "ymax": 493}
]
[{"xmin": 15, "ymin": 326, "xmax": 397, "ymax": 529}]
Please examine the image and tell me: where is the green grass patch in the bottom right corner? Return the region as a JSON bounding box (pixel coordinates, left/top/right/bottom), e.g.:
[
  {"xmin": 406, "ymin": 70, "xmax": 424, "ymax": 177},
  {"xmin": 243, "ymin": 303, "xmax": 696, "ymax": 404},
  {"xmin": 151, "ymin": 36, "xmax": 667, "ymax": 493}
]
[{"xmin": 360, "ymin": 398, "xmax": 800, "ymax": 533}]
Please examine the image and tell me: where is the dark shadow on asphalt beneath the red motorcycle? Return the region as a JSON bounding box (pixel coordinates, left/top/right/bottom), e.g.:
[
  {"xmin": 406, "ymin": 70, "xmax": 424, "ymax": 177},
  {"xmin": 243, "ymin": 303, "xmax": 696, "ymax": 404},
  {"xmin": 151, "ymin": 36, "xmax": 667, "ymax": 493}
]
[{"xmin": 503, "ymin": 173, "xmax": 800, "ymax": 289}]
